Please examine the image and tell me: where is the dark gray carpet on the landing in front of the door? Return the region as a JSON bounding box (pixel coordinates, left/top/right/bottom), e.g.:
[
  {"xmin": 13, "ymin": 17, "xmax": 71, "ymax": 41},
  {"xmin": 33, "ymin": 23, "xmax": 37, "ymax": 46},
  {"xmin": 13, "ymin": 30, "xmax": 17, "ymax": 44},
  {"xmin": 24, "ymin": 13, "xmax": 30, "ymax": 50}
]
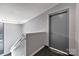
[{"xmin": 34, "ymin": 46, "xmax": 70, "ymax": 56}]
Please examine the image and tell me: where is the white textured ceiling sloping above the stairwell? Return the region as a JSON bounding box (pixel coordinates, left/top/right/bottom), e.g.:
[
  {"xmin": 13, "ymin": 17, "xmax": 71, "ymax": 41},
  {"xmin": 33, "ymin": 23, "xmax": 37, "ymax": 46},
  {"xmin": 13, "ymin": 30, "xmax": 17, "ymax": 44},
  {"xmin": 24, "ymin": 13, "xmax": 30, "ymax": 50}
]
[{"xmin": 0, "ymin": 3, "xmax": 56, "ymax": 24}]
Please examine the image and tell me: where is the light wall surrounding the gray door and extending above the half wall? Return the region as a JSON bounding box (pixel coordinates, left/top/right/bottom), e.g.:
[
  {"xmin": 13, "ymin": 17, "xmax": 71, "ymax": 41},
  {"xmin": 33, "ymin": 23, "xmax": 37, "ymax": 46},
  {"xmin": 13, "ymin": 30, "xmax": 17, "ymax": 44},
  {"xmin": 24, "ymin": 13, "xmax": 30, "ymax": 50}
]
[{"xmin": 23, "ymin": 3, "xmax": 76, "ymax": 55}]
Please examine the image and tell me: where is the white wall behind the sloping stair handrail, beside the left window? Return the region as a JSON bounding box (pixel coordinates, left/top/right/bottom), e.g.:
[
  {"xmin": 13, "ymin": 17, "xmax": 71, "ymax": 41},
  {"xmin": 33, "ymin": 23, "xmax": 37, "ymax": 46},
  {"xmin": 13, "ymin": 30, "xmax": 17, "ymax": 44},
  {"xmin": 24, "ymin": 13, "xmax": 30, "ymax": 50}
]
[{"xmin": 4, "ymin": 23, "xmax": 22, "ymax": 53}]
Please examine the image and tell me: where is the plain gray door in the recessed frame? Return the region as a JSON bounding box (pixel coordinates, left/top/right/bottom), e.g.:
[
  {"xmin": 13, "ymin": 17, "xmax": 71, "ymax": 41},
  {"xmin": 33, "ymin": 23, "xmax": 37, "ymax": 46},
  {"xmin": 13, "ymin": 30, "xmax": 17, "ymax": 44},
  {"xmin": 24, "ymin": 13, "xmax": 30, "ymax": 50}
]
[{"xmin": 49, "ymin": 11, "xmax": 69, "ymax": 52}]
